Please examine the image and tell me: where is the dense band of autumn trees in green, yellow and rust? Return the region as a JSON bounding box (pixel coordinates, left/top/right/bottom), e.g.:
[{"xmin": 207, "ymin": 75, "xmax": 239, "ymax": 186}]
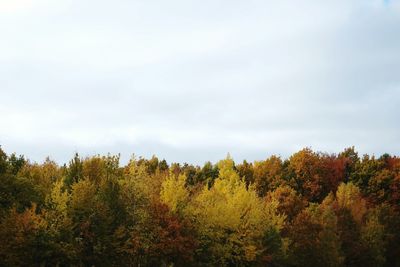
[{"xmin": 0, "ymin": 148, "xmax": 400, "ymax": 267}]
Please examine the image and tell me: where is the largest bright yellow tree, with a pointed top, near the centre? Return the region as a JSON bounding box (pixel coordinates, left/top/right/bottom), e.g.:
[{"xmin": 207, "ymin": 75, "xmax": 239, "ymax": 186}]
[{"xmin": 187, "ymin": 156, "xmax": 285, "ymax": 266}]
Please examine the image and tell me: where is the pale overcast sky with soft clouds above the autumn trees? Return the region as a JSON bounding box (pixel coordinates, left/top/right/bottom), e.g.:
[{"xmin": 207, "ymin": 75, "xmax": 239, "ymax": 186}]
[{"xmin": 0, "ymin": 0, "xmax": 400, "ymax": 164}]
